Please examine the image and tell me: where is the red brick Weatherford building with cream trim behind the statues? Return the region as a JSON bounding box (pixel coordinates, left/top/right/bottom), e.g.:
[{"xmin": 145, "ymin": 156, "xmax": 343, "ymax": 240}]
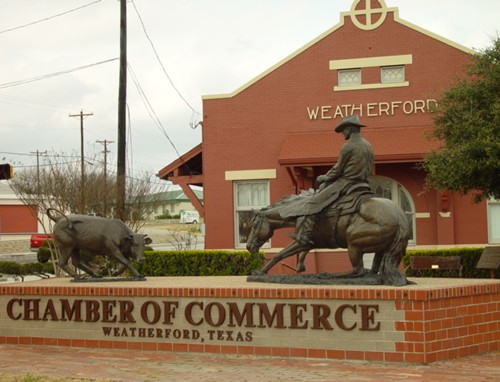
[{"xmin": 158, "ymin": 0, "xmax": 500, "ymax": 272}]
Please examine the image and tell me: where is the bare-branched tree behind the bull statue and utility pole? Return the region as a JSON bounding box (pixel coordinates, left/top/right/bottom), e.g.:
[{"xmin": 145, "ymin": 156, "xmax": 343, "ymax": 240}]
[{"xmin": 10, "ymin": 150, "xmax": 165, "ymax": 231}]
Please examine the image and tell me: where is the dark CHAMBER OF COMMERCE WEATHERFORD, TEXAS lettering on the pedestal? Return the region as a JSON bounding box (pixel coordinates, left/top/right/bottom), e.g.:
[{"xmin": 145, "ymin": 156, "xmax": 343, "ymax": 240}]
[{"xmin": 5, "ymin": 298, "xmax": 381, "ymax": 343}]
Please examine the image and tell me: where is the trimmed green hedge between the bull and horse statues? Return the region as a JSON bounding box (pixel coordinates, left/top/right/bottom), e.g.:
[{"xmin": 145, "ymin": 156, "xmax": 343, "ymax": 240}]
[{"xmin": 136, "ymin": 250, "xmax": 264, "ymax": 276}]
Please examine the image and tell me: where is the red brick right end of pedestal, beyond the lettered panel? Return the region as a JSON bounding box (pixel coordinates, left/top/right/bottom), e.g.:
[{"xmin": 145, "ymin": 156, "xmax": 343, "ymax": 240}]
[{"xmin": 396, "ymin": 285, "xmax": 500, "ymax": 363}]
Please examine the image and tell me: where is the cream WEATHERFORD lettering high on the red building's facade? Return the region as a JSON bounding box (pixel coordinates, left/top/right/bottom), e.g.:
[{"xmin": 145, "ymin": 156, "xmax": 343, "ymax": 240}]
[{"xmin": 306, "ymin": 99, "xmax": 437, "ymax": 120}]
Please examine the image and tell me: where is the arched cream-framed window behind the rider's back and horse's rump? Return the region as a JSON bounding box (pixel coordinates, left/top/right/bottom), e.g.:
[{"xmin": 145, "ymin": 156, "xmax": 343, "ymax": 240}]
[{"xmin": 370, "ymin": 176, "xmax": 416, "ymax": 244}]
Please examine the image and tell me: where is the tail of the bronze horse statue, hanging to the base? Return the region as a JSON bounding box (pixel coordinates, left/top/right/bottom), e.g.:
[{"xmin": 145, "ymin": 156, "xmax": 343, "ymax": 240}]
[{"xmin": 380, "ymin": 219, "xmax": 409, "ymax": 286}]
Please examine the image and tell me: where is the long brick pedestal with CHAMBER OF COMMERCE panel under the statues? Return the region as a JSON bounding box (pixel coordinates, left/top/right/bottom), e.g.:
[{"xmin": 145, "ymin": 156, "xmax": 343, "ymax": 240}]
[{"xmin": 0, "ymin": 277, "xmax": 500, "ymax": 363}]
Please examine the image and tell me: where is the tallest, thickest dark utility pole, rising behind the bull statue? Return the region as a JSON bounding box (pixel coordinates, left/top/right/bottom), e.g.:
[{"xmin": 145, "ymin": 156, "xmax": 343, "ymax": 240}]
[{"xmin": 116, "ymin": 0, "xmax": 127, "ymax": 220}]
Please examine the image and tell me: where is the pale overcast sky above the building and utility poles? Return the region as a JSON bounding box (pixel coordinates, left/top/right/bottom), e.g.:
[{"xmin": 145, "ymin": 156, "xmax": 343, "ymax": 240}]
[{"xmin": 0, "ymin": 0, "xmax": 500, "ymax": 179}]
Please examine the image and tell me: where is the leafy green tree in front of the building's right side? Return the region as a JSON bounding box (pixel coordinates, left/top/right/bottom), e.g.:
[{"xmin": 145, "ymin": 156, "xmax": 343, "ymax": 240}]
[{"xmin": 423, "ymin": 37, "xmax": 500, "ymax": 202}]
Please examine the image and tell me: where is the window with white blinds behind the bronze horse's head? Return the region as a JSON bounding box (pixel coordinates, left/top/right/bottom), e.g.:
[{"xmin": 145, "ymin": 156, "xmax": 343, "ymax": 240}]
[{"xmin": 234, "ymin": 180, "xmax": 269, "ymax": 248}]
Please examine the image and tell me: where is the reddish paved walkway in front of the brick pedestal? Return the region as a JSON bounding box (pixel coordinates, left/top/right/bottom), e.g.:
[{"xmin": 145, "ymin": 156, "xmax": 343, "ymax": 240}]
[{"xmin": 0, "ymin": 345, "xmax": 500, "ymax": 382}]
